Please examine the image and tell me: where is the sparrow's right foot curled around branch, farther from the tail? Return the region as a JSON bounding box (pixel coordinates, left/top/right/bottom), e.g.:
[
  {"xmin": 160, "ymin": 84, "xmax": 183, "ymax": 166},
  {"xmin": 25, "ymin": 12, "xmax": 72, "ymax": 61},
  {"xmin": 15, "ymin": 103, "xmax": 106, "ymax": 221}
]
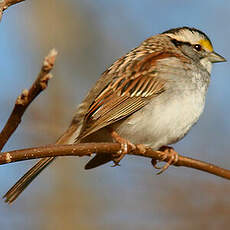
[{"xmin": 151, "ymin": 146, "xmax": 179, "ymax": 175}]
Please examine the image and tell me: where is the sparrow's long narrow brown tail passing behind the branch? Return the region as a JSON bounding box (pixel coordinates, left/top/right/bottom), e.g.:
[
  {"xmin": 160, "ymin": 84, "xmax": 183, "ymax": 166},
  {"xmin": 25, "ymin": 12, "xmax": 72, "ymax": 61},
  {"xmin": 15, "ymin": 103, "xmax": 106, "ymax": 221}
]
[{"xmin": 3, "ymin": 125, "xmax": 78, "ymax": 203}]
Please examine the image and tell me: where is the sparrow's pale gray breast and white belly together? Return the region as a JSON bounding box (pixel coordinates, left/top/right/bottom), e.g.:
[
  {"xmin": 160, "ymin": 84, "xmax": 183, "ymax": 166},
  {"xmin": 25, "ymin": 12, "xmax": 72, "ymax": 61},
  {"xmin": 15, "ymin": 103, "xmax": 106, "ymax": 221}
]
[{"xmin": 116, "ymin": 63, "xmax": 209, "ymax": 149}]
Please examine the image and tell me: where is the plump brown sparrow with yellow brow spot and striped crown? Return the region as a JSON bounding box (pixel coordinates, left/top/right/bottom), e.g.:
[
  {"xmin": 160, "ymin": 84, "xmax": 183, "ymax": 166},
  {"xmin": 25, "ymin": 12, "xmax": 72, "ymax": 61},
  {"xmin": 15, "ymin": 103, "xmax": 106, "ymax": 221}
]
[{"xmin": 4, "ymin": 26, "xmax": 226, "ymax": 203}]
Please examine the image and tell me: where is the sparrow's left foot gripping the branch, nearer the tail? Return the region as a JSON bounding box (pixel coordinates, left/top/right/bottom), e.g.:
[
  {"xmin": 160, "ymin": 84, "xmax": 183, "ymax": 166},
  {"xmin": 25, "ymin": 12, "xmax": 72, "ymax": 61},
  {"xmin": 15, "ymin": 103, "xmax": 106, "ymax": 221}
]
[{"xmin": 109, "ymin": 128, "xmax": 136, "ymax": 167}]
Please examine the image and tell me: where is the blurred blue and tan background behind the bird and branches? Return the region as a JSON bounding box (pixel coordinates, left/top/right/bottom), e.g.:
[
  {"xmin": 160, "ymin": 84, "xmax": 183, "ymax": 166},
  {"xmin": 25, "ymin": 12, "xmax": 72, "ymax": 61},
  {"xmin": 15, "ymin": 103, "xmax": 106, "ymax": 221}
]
[{"xmin": 0, "ymin": 0, "xmax": 230, "ymax": 230}]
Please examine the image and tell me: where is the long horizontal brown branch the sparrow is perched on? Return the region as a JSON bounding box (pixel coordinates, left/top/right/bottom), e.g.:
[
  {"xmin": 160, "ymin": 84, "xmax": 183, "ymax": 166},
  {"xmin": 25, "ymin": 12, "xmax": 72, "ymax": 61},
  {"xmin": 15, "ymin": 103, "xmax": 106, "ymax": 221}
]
[{"xmin": 0, "ymin": 143, "xmax": 230, "ymax": 179}]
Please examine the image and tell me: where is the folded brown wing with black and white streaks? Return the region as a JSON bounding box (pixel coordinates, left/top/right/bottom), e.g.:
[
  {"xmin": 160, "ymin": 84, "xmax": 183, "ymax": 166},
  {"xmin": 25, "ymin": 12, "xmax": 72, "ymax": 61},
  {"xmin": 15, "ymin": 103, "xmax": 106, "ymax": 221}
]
[{"xmin": 78, "ymin": 52, "xmax": 181, "ymax": 139}]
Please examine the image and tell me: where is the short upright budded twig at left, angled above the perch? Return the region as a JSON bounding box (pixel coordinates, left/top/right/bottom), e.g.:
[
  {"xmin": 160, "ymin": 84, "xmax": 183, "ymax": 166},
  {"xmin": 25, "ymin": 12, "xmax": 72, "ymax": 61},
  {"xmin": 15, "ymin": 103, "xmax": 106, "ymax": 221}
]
[{"xmin": 0, "ymin": 49, "xmax": 57, "ymax": 151}]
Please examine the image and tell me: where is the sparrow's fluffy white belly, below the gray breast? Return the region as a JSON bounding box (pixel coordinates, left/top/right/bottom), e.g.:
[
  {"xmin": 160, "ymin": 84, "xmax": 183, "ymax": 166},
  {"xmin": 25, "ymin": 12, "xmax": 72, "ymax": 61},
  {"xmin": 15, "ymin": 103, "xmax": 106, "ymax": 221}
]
[{"xmin": 116, "ymin": 92, "xmax": 204, "ymax": 149}]
